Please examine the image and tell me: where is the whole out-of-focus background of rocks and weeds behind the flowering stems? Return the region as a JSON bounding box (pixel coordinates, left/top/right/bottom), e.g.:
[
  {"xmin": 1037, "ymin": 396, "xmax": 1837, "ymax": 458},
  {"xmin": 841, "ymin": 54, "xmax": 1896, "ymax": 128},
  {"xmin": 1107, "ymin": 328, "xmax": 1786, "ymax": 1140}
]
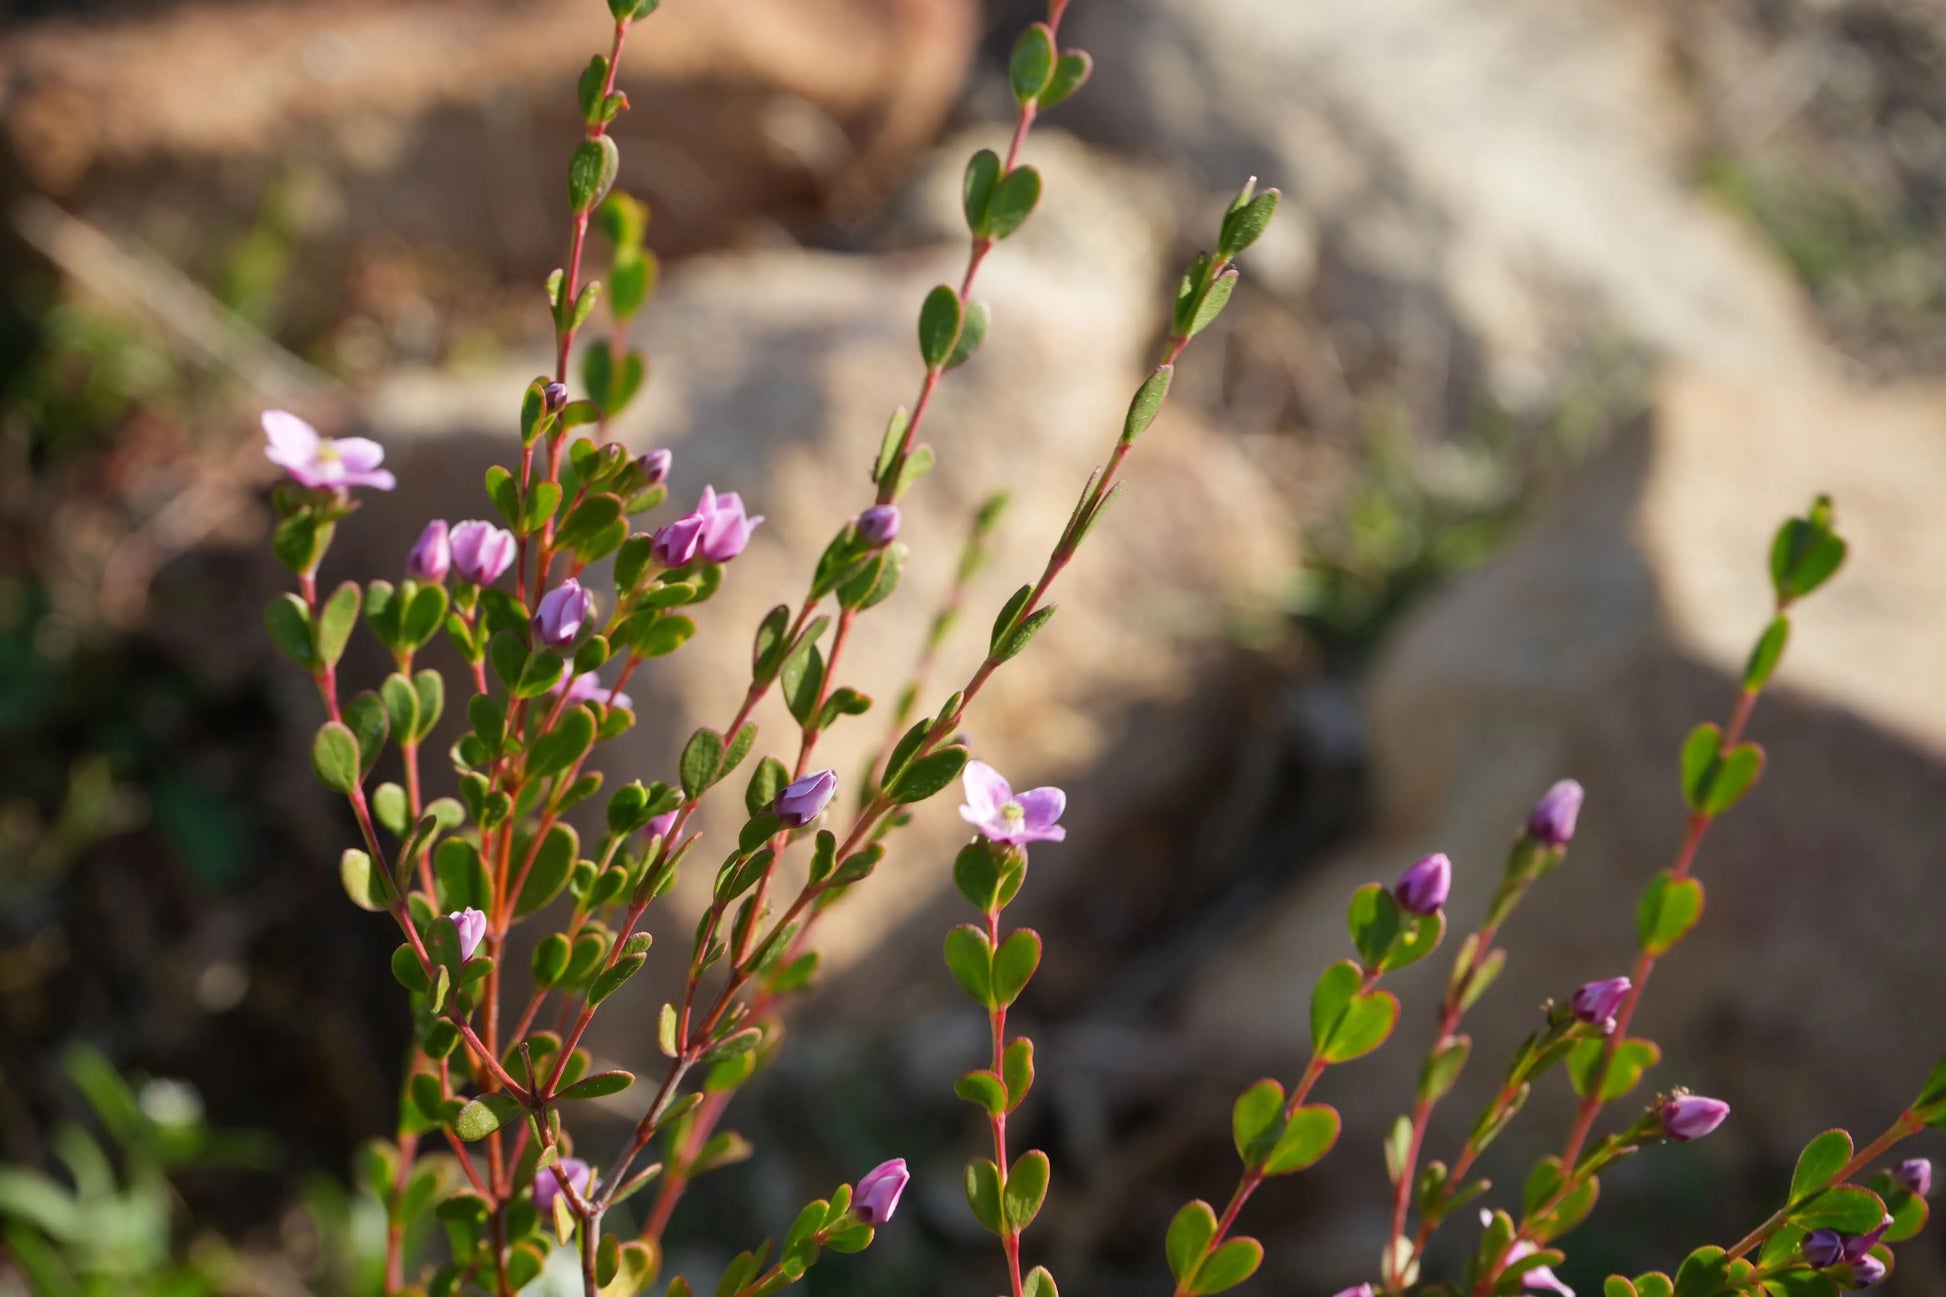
[{"xmin": 0, "ymin": 0, "xmax": 1946, "ymax": 1297}]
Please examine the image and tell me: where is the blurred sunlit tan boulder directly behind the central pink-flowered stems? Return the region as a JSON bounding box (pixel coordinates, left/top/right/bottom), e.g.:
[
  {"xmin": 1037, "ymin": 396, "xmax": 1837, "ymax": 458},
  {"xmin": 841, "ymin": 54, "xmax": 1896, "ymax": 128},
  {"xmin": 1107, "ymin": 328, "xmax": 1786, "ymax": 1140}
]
[{"xmin": 344, "ymin": 134, "xmax": 1292, "ymax": 1063}]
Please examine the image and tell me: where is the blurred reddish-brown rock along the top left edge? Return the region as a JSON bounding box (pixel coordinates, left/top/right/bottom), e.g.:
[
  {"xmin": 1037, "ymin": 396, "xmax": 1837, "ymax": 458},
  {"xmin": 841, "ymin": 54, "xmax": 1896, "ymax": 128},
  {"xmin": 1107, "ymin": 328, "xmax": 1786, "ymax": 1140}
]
[{"xmin": 0, "ymin": 0, "xmax": 977, "ymax": 335}]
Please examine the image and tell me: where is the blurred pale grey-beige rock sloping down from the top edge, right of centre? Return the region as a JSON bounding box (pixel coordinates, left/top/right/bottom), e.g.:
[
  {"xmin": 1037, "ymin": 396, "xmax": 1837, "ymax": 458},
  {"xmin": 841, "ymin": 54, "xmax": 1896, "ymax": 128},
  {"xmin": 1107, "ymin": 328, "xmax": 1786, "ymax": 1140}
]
[{"xmin": 1070, "ymin": 0, "xmax": 1821, "ymax": 399}]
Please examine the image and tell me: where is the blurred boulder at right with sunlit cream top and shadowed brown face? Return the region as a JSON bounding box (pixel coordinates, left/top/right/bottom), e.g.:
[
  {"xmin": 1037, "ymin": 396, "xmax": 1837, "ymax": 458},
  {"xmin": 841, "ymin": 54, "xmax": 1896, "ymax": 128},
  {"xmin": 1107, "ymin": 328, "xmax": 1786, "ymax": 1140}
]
[{"xmin": 1181, "ymin": 360, "xmax": 1946, "ymax": 1274}]
